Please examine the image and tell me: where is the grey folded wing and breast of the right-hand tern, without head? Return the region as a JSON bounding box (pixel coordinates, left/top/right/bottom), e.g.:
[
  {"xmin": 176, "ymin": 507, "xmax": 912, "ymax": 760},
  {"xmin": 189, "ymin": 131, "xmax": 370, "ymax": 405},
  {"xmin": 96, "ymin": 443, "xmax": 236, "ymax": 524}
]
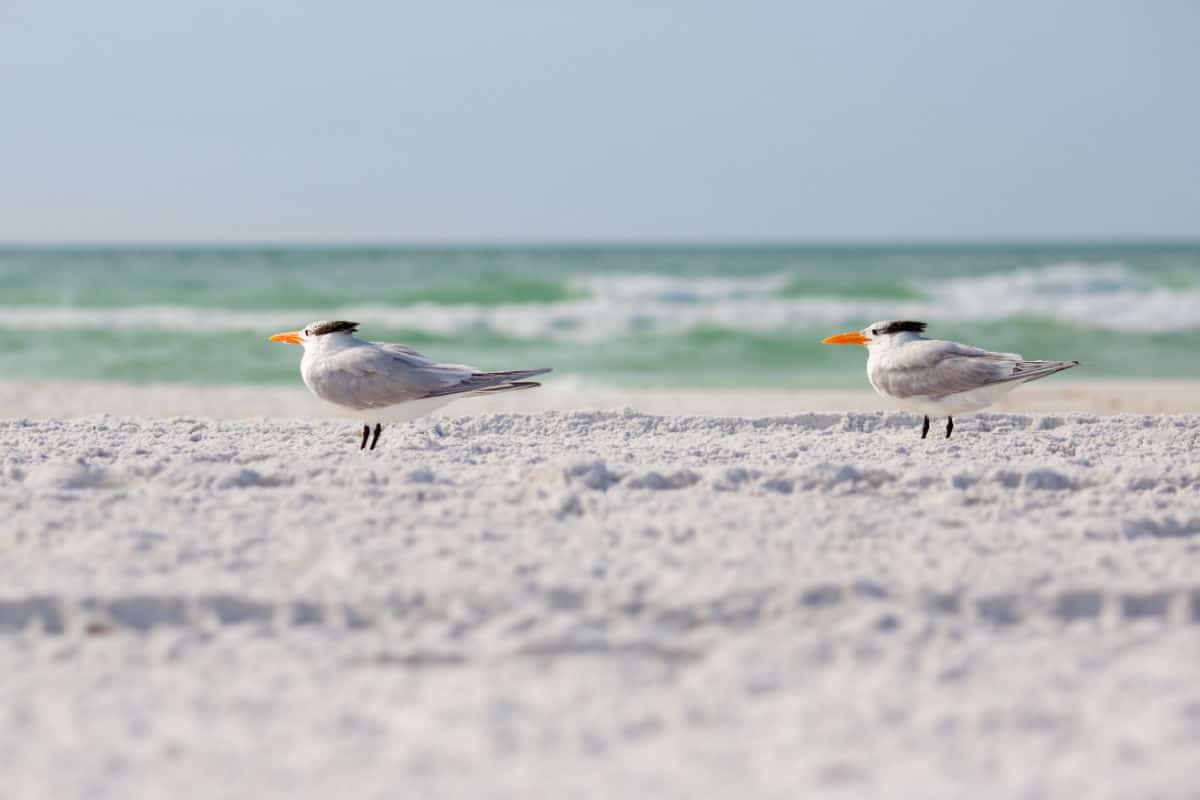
[{"xmin": 871, "ymin": 339, "xmax": 1079, "ymax": 398}]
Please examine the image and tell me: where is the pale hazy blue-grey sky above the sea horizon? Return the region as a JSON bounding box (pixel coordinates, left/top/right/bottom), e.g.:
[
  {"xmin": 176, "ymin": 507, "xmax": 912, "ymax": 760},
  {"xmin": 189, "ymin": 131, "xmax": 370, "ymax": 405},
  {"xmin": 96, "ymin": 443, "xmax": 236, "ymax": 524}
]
[{"xmin": 0, "ymin": 0, "xmax": 1200, "ymax": 241}]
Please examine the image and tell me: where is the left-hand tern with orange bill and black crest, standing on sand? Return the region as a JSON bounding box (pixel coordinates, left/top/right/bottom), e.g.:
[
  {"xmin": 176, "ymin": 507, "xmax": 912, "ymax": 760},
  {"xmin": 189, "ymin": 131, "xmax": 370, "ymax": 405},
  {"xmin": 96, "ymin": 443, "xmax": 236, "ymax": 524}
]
[{"xmin": 270, "ymin": 320, "xmax": 550, "ymax": 450}]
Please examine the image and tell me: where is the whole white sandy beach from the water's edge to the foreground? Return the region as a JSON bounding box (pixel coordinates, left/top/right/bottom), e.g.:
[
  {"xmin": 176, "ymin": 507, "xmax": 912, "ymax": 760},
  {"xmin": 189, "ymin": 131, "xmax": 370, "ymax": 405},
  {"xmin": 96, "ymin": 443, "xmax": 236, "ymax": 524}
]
[{"xmin": 0, "ymin": 384, "xmax": 1200, "ymax": 800}]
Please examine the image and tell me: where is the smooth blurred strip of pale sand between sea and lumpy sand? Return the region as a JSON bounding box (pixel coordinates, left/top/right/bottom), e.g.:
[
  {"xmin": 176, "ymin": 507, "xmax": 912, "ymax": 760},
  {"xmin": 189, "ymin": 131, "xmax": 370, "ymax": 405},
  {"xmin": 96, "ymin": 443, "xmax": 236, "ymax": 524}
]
[{"xmin": 0, "ymin": 377, "xmax": 1200, "ymax": 420}]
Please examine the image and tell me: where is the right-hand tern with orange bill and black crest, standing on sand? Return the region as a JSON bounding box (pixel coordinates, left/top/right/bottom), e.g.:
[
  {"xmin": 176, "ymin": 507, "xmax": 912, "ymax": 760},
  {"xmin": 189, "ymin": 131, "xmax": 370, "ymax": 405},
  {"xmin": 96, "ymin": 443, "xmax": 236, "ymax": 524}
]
[{"xmin": 822, "ymin": 320, "xmax": 1079, "ymax": 439}]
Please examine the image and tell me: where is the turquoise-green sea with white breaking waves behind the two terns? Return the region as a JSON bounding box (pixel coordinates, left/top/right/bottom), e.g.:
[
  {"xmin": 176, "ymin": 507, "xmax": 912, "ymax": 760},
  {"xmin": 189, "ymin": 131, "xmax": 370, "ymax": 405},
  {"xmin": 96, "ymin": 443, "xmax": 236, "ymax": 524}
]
[{"xmin": 0, "ymin": 245, "xmax": 1200, "ymax": 387}]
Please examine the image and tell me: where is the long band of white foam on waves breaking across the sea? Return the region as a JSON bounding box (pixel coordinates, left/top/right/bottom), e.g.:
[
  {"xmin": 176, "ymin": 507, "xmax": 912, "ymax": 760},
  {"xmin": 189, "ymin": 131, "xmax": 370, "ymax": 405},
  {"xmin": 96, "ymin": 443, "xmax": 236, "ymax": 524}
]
[{"xmin": 0, "ymin": 263, "xmax": 1200, "ymax": 341}]
